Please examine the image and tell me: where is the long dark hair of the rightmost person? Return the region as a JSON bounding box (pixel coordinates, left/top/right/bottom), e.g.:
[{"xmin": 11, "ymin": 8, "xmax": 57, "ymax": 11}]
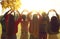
[{"xmin": 51, "ymin": 16, "xmax": 59, "ymax": 32}]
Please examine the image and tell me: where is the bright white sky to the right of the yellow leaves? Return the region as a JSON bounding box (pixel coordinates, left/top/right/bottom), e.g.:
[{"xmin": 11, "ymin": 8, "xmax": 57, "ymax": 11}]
[{"xmin": 21, "ymin": 0, "xmax": 60, "ymax": 11}]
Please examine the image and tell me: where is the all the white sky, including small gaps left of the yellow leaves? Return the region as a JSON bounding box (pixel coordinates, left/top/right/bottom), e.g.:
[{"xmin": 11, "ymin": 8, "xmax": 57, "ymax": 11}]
[{"xmin": 0, "ymin": 0, "xmax": 60, "ymax": 15}]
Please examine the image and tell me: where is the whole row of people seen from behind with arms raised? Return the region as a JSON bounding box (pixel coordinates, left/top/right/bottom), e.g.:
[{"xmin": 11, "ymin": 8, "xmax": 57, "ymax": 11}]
[{"xmin": 0, "ymin": 9, "xmax": 59, "ymax": 39}]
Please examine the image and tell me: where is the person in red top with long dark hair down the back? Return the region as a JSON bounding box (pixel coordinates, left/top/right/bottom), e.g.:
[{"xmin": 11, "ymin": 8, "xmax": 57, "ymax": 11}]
[{"xmin": 5, "ymin": 11, "xmax": 20, "ymax": 39}]
